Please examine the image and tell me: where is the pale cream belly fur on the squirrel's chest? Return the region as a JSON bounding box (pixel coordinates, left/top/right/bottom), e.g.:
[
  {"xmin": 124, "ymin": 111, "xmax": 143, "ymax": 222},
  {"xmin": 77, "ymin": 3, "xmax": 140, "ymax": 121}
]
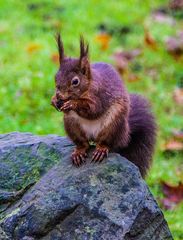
[{"xmin": 68, "ymin": 103, "xmax": 122, "ymax": 141}]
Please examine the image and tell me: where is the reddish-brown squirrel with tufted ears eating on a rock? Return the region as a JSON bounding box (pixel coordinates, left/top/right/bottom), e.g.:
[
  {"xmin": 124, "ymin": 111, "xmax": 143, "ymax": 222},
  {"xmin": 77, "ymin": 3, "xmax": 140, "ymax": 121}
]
[{"xmin": 51, "ymin": 34, "xmax": 156, "ymax": 177}]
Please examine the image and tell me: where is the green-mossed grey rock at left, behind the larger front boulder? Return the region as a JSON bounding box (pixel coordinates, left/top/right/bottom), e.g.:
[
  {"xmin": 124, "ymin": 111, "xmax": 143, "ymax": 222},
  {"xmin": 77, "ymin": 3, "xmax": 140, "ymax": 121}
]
[{"xmin": 0, "ymin": 133, "xmax": 73, "ymax": 191}]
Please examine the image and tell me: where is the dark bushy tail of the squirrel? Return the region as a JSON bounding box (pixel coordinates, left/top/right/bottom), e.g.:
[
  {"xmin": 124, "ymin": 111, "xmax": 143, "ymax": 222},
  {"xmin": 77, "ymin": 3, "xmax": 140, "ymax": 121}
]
[{"xmin": 120, "ymin": 94, "xmax": 156, "ymax": 177}]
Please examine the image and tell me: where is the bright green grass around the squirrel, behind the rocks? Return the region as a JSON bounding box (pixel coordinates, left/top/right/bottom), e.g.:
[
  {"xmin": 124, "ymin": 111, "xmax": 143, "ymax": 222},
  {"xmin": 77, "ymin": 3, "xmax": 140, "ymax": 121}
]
[{"xmin": 0, "ymin": 0, "xmax": 183, "ymax": 240}]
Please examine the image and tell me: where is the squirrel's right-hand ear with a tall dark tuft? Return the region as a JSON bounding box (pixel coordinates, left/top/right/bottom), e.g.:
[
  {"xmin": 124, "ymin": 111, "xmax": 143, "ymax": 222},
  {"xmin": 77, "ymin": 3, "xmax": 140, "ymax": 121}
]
[{"xmin": 79, "ymin": 36, "xmax": 90, "ymax": 75}]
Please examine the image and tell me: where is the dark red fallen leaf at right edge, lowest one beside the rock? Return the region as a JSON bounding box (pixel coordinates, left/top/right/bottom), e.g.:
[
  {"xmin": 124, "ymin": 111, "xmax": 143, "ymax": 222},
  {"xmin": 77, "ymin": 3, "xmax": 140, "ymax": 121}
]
[{"xmin": 161, "ymin": 181, "xmax": 183, "ymax": 209}]
